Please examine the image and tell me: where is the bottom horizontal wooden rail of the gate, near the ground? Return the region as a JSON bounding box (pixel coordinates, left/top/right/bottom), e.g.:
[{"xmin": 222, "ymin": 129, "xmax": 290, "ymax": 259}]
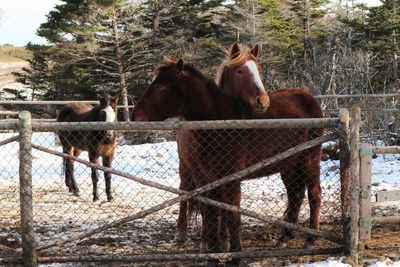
[{"xmin": 0, "ymin": 247, "xmax": 343, "ymax": 263}]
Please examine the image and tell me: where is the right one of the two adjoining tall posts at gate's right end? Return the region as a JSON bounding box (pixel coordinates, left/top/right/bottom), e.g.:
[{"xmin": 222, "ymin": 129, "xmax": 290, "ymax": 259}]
[{"xmin": 345, "ymin": 106, "xmax": 361, "ymax": 266}]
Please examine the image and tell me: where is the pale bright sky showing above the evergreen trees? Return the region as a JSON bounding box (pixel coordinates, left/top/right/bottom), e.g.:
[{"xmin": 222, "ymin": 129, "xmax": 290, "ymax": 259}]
[{"xmin": 0, "ymin": 0, "xmax": 380, "ymax": 46}]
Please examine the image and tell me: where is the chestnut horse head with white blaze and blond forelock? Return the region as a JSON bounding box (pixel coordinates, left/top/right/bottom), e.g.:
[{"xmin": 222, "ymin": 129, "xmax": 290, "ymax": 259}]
[{"xmin": 216, "ymin": 43, "xmax": 269, "ymax": 113}]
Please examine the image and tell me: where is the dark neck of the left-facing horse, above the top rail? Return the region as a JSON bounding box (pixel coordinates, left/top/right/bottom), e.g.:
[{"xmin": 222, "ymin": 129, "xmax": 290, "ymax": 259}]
[{"xmin": 185, "ymin": 78, "xmax": 245, "ymax": 120}]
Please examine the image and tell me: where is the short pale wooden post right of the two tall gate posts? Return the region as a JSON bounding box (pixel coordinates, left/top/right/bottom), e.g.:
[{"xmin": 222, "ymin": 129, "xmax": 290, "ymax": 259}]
[{"xmin": 359, "ymin": 143, "xmax": 373, "ymax": 240}]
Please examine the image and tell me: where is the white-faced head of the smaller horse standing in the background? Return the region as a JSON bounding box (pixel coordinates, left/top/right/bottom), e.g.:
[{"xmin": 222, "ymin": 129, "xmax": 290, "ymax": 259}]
[{"xmin": 98, "ymin": 94, "xmax": 118, "ymax": 144}]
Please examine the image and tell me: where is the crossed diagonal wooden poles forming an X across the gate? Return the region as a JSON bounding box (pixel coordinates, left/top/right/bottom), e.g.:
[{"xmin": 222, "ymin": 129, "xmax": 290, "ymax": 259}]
[{"xmin": 36, "ymin": 133, "xmax": 342, "ymax": 250}]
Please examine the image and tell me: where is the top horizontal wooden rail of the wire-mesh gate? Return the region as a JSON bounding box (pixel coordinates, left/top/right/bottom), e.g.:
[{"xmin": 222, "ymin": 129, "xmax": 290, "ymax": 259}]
[{"xmin": 32, "ymin": 118, "xmax": 339, "ymax": 132}]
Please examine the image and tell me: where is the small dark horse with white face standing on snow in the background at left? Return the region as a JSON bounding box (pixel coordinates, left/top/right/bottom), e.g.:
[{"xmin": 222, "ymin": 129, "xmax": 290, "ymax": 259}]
[{"xmin": 57, "ymin": 95, "xmax": 118, "ymax": 202}]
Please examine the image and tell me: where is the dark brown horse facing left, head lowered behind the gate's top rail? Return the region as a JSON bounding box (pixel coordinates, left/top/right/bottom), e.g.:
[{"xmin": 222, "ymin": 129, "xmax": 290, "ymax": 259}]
[{"xmin": 133, "ymin": 58, "xmax": 320, "ymax": 260}]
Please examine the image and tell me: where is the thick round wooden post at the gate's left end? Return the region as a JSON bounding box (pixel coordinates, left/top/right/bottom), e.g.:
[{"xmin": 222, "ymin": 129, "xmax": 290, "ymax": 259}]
[{"xmin": 19, "ymin": 111, "xmax": 37, "ymax": 267}]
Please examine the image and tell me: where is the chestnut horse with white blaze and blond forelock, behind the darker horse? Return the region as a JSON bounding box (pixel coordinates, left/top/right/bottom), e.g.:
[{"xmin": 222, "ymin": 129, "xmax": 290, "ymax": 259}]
[{"xmin": 175, "ymin": 43, "xmax": 324, "ymax": 250}]
